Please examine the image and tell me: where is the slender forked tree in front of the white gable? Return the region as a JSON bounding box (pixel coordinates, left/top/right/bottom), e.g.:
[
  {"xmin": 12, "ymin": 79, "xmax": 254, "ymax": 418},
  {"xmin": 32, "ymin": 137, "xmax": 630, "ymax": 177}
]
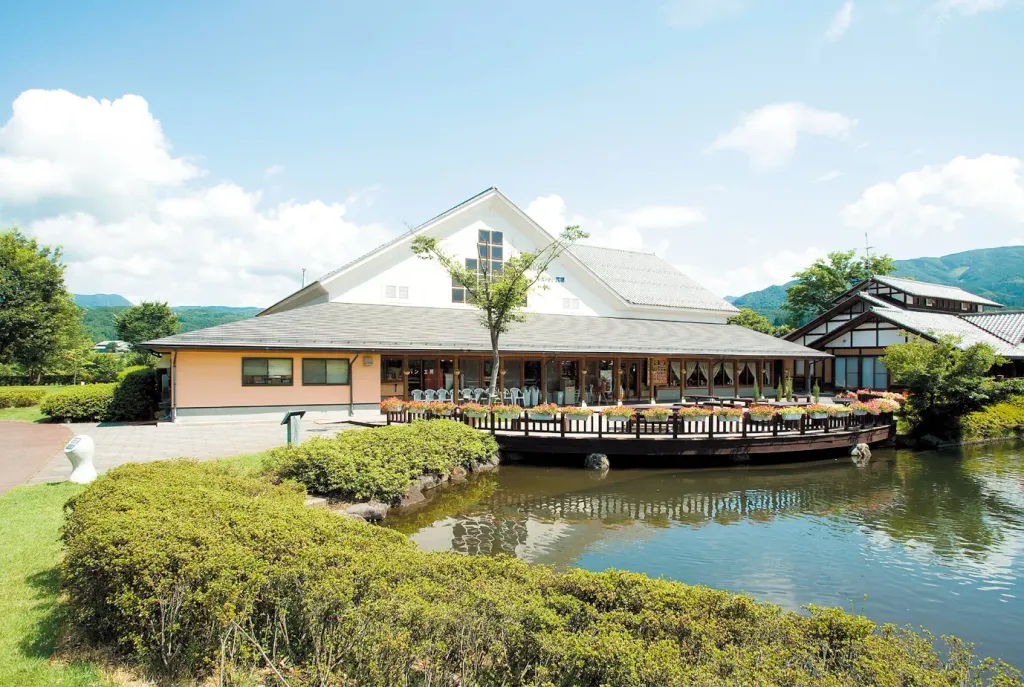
[{"xmin": 413, "ymin": 226, "xmax": 590, "ymax": 399}]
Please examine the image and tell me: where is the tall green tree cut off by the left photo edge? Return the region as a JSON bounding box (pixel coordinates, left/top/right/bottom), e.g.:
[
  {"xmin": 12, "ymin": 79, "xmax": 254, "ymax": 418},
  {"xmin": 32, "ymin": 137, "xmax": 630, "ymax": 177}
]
[{"xmin": 0, "ymin": 228, "xmax": 82, "ymax": 378}]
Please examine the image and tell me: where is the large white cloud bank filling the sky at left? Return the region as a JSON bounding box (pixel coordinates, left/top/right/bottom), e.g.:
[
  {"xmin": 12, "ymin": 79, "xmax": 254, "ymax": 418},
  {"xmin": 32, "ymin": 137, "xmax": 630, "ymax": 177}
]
[{"xmin": 0, "ymin": 91, "xmax": 393, "ymax": 305}]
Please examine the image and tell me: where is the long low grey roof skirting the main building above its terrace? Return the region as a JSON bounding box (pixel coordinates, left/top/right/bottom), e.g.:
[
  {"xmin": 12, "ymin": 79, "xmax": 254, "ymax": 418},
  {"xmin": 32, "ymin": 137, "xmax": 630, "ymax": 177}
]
[{"xmin": 145, "ymin": 303, "xmax": 828, "ymax": 358}]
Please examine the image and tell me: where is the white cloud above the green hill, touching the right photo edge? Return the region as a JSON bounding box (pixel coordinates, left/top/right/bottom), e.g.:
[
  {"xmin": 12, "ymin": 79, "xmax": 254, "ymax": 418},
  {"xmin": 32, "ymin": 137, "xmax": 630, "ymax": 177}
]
[{"xmin": 841, "ymin": 155, "xmax": 1024, "ymax": 235}]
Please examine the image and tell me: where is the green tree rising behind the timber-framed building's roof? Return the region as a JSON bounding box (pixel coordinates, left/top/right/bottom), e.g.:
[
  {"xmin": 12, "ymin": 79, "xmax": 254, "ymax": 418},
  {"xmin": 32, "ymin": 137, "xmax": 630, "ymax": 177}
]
[{"xmin": 782, "ymin": 251, "xmax": 896, "ymax": 325}]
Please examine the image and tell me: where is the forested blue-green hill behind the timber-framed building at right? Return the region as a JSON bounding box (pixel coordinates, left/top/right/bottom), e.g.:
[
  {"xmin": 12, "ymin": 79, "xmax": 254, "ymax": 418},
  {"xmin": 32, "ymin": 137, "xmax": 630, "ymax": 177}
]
[{"xmin": 726, "ymin": 246, "xmax": 1024, "ymax": 325}]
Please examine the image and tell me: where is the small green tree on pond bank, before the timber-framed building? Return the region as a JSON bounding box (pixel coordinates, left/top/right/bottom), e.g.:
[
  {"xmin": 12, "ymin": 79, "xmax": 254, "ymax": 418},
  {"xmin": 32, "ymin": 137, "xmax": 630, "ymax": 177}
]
[{"xmin": 882, "ymin": 335, "xmax": 1001, "ymax": 436}]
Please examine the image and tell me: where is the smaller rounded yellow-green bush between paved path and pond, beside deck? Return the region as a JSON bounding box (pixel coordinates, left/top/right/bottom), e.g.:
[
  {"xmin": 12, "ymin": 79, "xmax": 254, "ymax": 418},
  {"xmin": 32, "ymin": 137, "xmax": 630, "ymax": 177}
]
[{"xmin": 267, "ymin": 420, "xmax": 498, "ymax": 501}]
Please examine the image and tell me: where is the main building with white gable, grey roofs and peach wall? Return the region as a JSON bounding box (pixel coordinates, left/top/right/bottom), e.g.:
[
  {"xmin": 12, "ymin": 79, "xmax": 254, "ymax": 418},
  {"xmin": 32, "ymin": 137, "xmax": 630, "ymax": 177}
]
[{"xmin": 147, "ymin": 188, "xmax": 830, "ymax": 421}]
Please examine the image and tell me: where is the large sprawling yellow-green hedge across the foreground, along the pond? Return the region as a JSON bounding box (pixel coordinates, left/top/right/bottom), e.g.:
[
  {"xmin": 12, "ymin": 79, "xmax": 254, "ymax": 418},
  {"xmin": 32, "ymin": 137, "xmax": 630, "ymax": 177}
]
[{"xmin": 61, "ymin": 461, "xmax": 1021, "ymax": 687}]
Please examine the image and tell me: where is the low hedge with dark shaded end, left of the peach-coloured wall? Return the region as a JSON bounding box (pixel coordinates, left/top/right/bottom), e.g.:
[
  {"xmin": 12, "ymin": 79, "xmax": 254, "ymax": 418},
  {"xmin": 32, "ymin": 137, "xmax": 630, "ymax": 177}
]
[{"xmin": 40, "ymin": 368, "xmax": 159, "ymax": 422}]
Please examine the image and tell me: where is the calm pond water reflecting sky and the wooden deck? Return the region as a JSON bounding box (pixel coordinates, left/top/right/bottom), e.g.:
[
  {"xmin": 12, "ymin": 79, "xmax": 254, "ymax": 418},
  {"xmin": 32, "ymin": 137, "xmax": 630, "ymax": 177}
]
[{"xmin": 388, "ymin": 444, "xmax": 1024, "ymax": 665}]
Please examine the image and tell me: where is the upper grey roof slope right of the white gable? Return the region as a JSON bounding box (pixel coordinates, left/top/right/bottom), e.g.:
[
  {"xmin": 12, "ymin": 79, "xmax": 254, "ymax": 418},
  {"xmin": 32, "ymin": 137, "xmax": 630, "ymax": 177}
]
[{"xmin": 569, "ymin": 245, "xmax": 739, "ymax": 312}]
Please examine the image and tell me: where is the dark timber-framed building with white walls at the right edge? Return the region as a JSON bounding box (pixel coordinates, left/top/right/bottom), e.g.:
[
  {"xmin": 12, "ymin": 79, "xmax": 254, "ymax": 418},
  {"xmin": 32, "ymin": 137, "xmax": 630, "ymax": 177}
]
[{"xmin": 786, "ymin": 276, "xmax": 1024, "ymax": 389}]
